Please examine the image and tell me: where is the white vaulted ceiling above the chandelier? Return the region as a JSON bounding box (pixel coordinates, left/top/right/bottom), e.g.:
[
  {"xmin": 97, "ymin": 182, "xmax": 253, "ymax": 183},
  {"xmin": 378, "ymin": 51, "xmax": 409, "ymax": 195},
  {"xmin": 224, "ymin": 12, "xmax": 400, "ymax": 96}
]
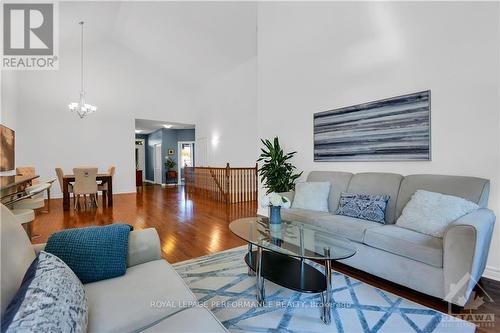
[{"xmin": 59, "ymin": 1, "xmax": 257, "ymax": 86}]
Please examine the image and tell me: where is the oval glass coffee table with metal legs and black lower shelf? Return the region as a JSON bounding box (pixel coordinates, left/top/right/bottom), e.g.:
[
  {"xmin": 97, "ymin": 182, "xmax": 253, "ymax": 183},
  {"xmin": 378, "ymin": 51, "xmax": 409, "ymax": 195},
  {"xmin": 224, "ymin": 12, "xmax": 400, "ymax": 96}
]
[{"xmin": 229, "ymin": 216, "xmax": 356, "ymax": 324}]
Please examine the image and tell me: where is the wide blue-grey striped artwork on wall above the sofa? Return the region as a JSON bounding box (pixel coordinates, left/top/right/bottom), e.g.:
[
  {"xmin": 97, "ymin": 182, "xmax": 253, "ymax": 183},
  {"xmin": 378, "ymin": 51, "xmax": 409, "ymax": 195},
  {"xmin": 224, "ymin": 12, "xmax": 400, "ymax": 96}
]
[{"xmin": 314, "ymin": 90, "xmax": 431, "ymax": 162}]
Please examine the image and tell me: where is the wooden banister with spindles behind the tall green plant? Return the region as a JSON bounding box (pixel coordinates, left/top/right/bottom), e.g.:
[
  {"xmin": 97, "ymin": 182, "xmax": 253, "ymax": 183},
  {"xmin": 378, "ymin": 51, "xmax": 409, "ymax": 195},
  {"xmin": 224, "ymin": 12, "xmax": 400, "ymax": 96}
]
[{"xmin": 184, "ymin": 163, "xmax": 258, "ymax": 204}]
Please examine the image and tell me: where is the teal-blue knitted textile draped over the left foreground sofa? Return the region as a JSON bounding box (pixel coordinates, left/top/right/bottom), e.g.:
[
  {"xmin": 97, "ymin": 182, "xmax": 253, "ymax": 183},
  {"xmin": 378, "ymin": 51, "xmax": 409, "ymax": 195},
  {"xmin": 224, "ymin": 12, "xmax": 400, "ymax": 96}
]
[{"xmin": 45, "ymin": 224, "xmax": 133, "ymax": 283}]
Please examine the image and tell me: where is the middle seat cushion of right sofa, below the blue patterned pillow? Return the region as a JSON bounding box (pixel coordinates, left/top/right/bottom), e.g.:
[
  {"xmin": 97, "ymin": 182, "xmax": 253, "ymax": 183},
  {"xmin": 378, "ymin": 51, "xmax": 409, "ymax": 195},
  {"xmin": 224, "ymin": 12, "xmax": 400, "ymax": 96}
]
[{"xmin": 311, "ymin": 215, "xmax": 380, "ymax": 243}]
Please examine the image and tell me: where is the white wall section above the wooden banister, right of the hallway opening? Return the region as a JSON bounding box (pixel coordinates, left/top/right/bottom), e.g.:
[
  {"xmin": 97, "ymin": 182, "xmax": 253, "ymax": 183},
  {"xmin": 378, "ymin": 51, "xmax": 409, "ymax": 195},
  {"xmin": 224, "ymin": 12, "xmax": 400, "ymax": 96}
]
[{"xmin": 195, "ymin": 58, "xmax": 258, "ymax": 167}]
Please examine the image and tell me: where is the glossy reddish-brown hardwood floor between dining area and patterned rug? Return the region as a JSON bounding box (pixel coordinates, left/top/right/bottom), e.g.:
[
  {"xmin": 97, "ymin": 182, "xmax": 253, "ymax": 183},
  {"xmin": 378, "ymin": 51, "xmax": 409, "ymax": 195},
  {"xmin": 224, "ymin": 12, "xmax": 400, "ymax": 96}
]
[{"xmin": 33, "ymin": 185, "xmax": 252, "ymax": 263}]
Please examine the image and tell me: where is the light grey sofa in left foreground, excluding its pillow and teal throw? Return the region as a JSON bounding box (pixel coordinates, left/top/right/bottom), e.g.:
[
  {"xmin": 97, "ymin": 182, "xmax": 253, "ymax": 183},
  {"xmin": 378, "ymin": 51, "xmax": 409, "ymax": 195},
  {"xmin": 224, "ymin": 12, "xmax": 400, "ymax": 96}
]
[{"xmin": 0, "ymin": 205, "xmax": 227, "ymax": 333}]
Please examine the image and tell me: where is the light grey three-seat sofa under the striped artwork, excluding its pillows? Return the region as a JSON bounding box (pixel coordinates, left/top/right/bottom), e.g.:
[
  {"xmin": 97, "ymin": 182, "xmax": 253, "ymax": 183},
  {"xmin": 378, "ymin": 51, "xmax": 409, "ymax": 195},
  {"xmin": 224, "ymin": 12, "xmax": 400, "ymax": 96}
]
[{"xmin": 282, "ymin": 171, "xmax": 495, "ymax": 306}]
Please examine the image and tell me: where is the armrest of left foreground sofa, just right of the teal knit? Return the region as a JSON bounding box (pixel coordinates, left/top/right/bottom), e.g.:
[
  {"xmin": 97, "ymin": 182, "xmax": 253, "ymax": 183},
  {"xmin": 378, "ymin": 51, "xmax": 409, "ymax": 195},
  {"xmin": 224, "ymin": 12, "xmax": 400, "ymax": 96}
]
[{"xmin": 127, "ymin": 228, "xmax": 161, "ymax": 267}]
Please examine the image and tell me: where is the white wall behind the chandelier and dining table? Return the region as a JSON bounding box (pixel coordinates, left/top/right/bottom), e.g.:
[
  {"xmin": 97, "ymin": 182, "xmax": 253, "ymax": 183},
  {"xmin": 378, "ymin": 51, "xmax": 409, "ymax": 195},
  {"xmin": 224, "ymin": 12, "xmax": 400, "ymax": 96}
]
[{"xmin": 2, "ymin": 40, "xmax": 194, "ymax": 196}]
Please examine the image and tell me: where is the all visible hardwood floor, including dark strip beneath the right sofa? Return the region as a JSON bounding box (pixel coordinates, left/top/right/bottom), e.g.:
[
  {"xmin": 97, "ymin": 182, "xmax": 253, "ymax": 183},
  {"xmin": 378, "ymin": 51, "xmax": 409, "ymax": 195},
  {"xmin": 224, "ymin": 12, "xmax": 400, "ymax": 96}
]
[{"xmin": 33, "ymin": 185, "xmax": 500, "ymax": 333}]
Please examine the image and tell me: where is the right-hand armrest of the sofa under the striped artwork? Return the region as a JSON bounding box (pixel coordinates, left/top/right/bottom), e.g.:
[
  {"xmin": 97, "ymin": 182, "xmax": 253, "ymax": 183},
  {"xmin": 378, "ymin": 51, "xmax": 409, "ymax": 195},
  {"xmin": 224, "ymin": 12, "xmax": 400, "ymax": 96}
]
[{"xmin": 443, "ymin": 208, "xmax": 495, "ymax": 306}]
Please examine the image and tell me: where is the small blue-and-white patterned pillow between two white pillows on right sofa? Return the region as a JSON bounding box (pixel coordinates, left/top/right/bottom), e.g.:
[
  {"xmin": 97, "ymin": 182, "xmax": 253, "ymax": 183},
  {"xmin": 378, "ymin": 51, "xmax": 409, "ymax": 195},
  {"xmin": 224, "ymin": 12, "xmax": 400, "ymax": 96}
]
[{"xmin": 336, "ymin": 193, "xmax": 390, "ymax": 224}]
